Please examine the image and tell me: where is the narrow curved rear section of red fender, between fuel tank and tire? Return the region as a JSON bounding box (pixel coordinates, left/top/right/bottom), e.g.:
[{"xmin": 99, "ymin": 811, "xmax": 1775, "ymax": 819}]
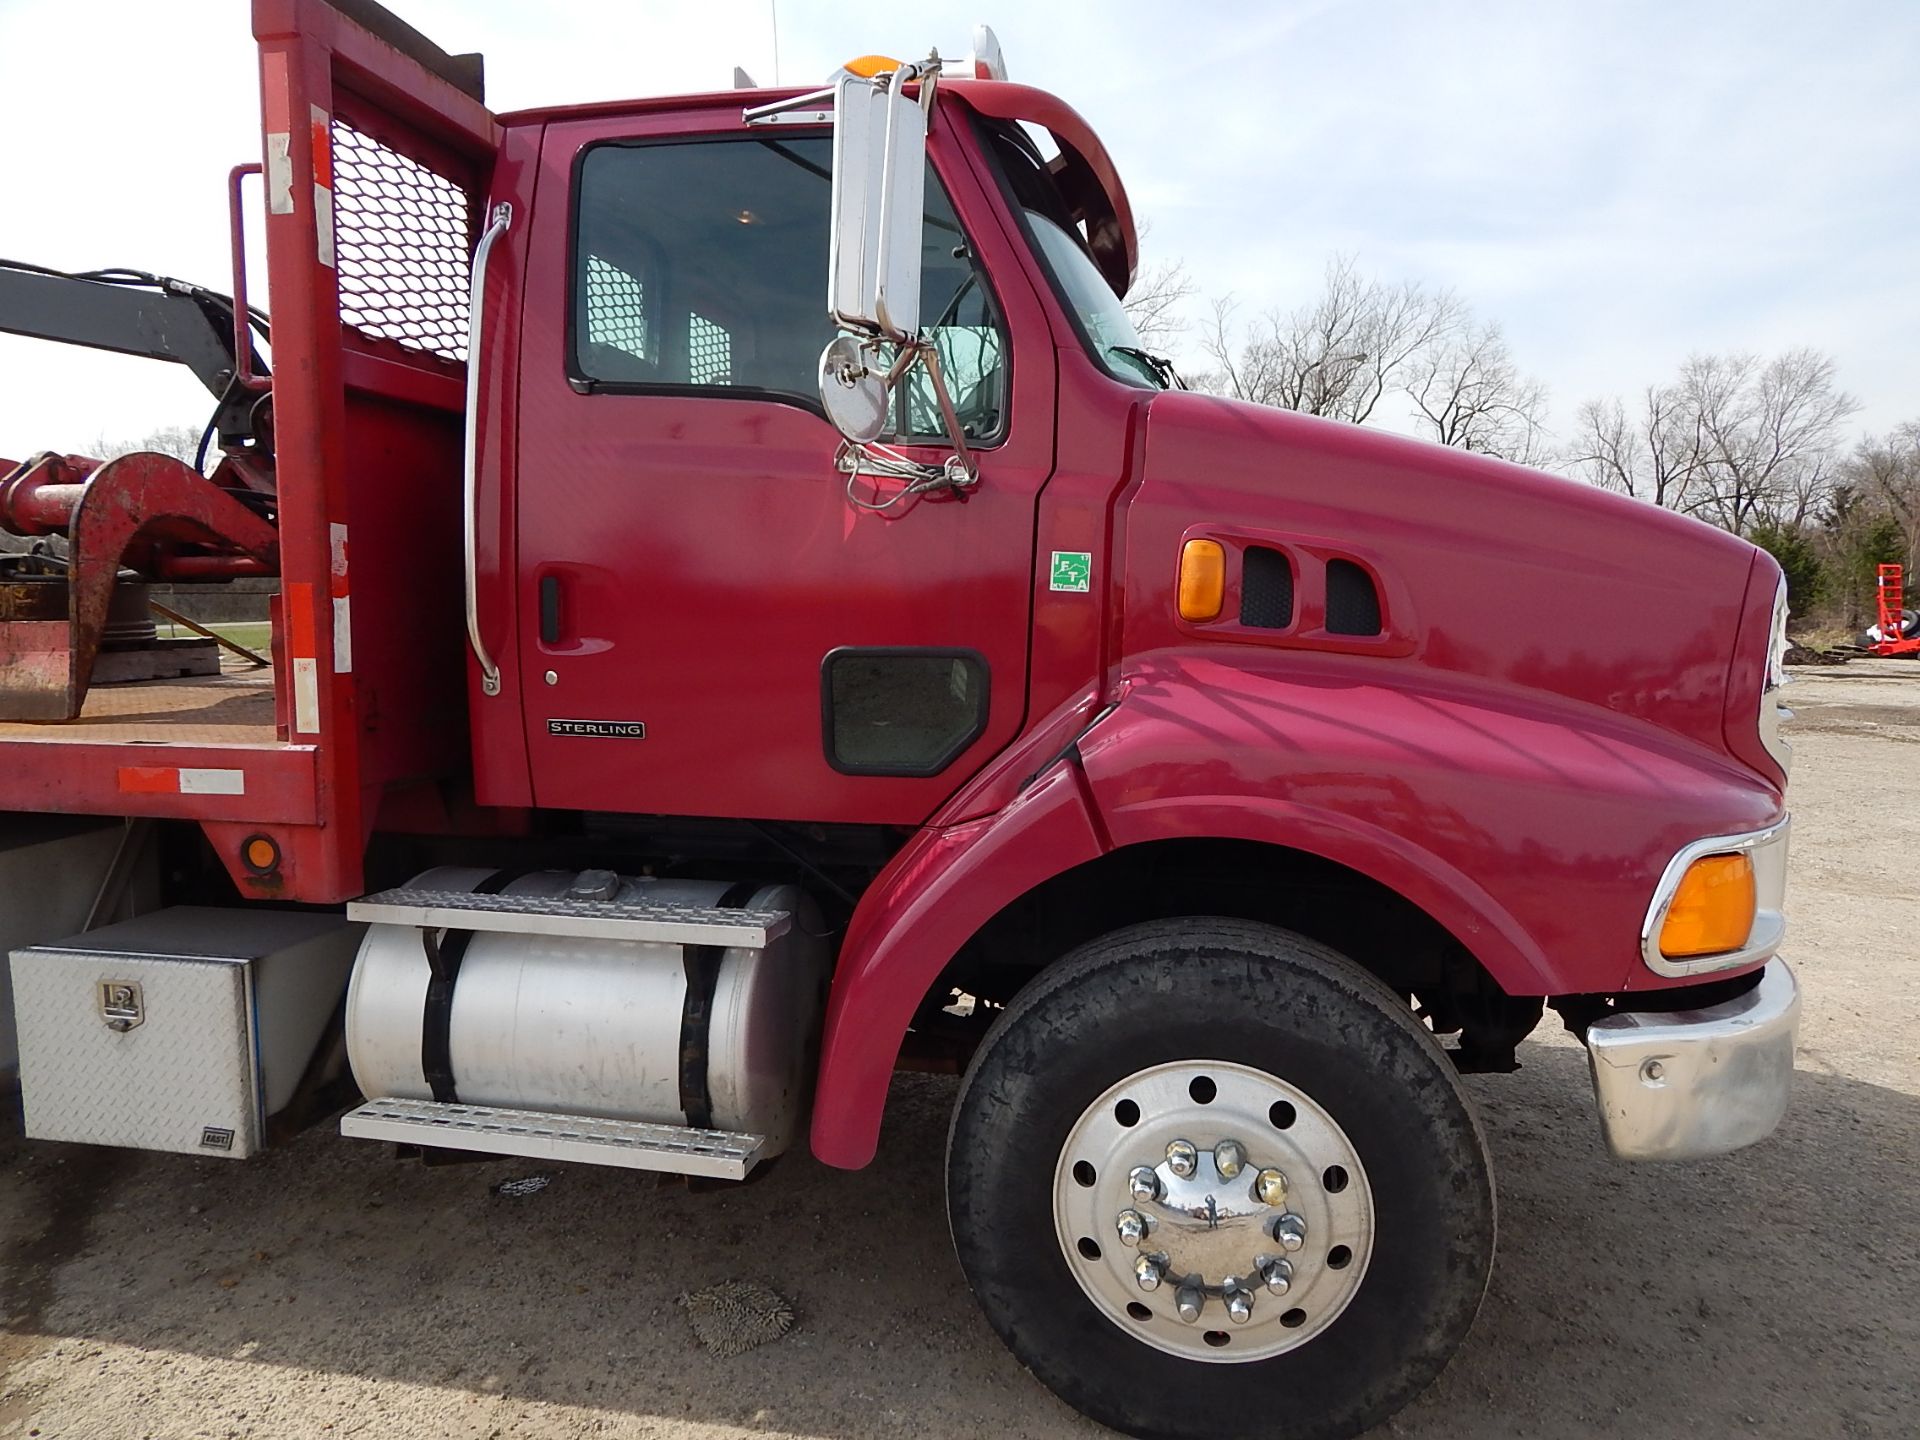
[{"xmin": 812, "ymin": 764, "xmax": 1104, "ymax": 1169}]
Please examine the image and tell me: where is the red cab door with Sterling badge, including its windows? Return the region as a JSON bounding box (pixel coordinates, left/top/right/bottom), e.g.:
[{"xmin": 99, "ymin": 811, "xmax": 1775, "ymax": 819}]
[{"xmin": 515, "ymin": 100, "xmax": 1054, "ymax": 824}]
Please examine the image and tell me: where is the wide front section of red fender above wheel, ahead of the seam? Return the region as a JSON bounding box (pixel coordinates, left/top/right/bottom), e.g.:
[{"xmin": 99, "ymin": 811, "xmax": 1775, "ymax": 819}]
[{"xmin": 1079, "ymin": 647, "xmax": 1782, "ymax": 995}]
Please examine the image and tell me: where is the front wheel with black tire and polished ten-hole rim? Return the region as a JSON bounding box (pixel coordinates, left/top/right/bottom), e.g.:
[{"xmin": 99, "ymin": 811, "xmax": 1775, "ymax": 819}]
[{"xmin": 947, "ymin": 920, "xmax": 1494, "ymax": 1440}]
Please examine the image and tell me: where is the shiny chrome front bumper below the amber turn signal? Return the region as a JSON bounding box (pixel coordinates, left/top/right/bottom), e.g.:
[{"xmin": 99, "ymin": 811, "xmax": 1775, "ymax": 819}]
[{"xmin": 1586, "ymin": 958, "xmax": 1799, "ymax": 1160}]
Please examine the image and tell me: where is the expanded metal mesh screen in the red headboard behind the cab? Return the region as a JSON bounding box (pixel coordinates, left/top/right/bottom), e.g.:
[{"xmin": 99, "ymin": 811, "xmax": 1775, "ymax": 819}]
[{"xmin": 332, "ymin": 119, "xmax": 472, "ymax": 361}]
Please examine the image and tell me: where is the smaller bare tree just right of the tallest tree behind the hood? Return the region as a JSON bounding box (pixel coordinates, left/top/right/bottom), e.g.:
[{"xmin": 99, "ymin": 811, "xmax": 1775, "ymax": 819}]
[{"xmin": 1404, "ymin": 321, "xmax": 1548, "ymax": 465}]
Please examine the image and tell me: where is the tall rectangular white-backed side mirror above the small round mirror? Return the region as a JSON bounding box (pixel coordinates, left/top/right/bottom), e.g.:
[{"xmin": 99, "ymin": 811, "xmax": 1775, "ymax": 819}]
[{"xmin": 828, "ymin": 65, "xmax": 931, "ymax": 342}]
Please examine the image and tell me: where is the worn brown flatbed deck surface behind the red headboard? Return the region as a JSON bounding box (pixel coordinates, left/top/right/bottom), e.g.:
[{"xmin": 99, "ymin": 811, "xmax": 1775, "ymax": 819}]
[{"xmin": 0, "ymin": 655, "xmax": 278, "ymax": 747}]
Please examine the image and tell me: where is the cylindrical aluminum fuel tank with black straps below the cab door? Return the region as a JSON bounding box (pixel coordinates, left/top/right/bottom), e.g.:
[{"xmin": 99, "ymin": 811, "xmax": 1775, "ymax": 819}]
[{"xmin": 348, "ymin": 866, "xmax": 828, "ymax": 1154}]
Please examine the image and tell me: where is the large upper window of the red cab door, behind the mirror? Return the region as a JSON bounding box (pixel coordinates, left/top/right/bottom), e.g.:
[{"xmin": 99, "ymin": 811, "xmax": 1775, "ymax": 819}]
[{"xmin": 572, "ymin": 136, "xmax": 1008, "ymax": 442}]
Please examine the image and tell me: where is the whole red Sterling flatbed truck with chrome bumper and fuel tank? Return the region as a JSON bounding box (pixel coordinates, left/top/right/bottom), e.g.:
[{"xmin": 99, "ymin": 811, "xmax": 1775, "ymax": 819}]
[{"xmin": 0, "ymin": 0, "xmax": 1797, "ymax": 1436}]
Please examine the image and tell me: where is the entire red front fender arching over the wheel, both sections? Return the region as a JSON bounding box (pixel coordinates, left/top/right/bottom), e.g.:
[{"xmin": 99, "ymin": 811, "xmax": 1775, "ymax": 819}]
[{"xmin": 812, "ymin": 649, "xmax": 1780, "ymax": 1169}]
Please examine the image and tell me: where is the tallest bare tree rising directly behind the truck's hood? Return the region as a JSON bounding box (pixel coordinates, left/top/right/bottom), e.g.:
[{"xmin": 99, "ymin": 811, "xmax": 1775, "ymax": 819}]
[{"xmin": 1202, "ymin": 255, "xmax": 1465, "ymax": 424}]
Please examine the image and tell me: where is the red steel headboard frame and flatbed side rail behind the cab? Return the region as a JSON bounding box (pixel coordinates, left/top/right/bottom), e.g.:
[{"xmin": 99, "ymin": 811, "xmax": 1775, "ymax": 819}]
[{"xmin": 0, "ymin": 0, "xmax": 499, "ymax": 902}]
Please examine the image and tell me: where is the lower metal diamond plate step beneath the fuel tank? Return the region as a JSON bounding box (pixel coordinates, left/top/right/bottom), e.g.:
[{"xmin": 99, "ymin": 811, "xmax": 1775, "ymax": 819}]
[{"xmin": 340, "ymin": 1100, "xmax": 766, "ymax": 1181}]
